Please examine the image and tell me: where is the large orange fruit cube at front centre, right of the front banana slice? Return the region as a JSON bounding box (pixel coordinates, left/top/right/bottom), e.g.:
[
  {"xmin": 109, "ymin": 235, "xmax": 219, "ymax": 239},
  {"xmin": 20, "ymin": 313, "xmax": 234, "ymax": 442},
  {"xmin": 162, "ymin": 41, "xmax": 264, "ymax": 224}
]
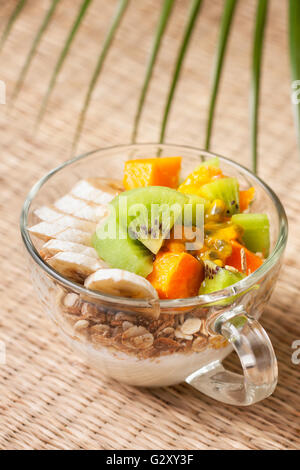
[{"xmin": 147, "ymin": 251, "xmax": 204, "ymax": 299}]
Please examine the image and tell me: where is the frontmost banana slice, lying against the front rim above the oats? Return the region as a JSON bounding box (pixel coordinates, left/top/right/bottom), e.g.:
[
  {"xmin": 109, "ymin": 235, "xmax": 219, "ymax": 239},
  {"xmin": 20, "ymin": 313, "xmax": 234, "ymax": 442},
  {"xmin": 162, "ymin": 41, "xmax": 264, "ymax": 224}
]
[{"xmin": 84, "ymin": 269, "xmax": 160, "ymax": 318}]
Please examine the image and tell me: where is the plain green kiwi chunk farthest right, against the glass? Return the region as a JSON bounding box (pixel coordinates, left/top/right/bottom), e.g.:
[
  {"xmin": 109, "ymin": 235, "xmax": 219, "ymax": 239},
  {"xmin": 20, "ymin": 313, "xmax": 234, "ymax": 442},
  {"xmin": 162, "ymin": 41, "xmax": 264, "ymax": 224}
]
[{"xmin": 232, "ymin": 213, "xmax": 270, "ymax": 258}]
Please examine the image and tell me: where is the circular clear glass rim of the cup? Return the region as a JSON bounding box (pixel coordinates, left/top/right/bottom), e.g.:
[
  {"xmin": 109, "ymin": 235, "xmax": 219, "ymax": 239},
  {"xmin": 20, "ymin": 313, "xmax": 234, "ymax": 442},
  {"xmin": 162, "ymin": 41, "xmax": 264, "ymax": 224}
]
[{"xmin": 20, "ymin": 142, "xmax": 288, "ymax": 309}]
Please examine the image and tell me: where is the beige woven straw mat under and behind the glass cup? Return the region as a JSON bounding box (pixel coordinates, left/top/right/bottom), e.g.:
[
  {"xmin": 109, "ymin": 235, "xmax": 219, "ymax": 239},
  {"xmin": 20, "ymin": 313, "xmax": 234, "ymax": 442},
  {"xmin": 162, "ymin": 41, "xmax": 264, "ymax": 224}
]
[{"xmin": 0, "ymin": 0, "xmax": 300, "ymax": 450}]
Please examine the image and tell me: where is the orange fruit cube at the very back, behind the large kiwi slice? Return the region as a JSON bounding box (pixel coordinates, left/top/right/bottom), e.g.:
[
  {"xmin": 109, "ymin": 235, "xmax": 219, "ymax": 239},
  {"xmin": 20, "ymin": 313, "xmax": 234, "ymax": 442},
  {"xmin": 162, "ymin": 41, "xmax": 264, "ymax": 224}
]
[{"xmin": 123, "ymin": 157, "xmax": 181, "ymax": 190}]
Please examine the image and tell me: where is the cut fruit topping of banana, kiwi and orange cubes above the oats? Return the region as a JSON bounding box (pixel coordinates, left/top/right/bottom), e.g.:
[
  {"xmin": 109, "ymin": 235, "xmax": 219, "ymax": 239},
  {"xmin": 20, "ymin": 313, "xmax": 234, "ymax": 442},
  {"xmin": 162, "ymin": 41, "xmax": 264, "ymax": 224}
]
[{"xmin": 29, "ymin": 157, "xmax": 269, "ymax": 299}]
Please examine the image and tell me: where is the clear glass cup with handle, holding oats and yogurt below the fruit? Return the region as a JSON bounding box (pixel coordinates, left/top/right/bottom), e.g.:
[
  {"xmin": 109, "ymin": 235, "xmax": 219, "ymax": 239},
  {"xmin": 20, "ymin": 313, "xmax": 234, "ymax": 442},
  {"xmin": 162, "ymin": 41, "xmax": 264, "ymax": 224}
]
[{"xmin": 21, "ymin": 144, "xmax": 288, "ymax": 405}]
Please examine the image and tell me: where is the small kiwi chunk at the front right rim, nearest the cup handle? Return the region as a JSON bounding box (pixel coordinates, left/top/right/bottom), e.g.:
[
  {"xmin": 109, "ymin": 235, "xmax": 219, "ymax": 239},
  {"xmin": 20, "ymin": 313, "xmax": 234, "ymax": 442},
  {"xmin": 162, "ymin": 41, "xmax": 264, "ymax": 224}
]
[{"xmin": 199, "ymin": 261, "xmax": 245, "ymax": 295}]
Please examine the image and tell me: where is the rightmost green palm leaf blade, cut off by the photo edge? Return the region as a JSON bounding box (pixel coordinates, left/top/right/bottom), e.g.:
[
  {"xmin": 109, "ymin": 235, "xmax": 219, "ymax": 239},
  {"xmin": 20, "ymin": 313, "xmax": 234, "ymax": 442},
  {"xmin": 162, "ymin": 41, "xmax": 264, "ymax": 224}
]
[{"xmin": 289, "ymin": 0, "xmax": 300, "ymax": 152}]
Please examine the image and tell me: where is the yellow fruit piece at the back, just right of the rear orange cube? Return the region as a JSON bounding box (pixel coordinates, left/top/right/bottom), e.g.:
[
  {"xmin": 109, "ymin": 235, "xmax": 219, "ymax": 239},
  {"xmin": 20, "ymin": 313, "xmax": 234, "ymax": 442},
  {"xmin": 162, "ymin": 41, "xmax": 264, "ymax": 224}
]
[{"xmin": 178, "ymin": 166, "xmax": 224, "ymax": 196}]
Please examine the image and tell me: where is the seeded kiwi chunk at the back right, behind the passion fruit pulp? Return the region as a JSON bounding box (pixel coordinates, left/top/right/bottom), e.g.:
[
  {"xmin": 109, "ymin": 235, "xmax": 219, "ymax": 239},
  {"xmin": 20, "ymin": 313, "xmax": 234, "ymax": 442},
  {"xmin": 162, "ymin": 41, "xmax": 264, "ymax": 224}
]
[{"xmin": 201, "ymin": 178, "xmax": 240, "ymax": 215}]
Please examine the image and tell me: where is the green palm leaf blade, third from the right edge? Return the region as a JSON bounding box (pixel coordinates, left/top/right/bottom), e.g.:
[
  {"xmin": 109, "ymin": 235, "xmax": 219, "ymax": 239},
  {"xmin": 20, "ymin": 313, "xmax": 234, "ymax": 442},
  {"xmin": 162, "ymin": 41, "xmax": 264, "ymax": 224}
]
[{"xmin": 205, "ymin": 0, "xmax": 237, "ymax": 150}]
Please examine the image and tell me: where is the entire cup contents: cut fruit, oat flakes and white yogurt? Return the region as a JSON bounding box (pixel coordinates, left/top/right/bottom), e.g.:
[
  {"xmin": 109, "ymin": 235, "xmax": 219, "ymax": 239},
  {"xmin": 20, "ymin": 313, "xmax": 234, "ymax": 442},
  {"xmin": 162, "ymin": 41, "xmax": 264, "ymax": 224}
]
[{"xmin": 29, "ymin": 157, "xmax": 269, "ymax": 385}]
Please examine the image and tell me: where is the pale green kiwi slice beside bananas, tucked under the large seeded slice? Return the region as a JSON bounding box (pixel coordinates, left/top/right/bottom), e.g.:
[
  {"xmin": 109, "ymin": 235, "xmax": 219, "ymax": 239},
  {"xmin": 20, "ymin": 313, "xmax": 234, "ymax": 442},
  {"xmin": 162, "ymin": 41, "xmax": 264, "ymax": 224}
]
[{"xmin": 92, "ymin": 217, "xmax": 153, "ymax": 277}]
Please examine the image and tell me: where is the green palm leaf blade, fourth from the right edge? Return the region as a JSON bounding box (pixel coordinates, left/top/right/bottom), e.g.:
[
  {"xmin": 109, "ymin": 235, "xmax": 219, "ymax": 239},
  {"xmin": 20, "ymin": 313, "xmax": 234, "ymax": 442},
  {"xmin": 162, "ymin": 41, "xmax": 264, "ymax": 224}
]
[{"xmin": 160, "ymin": 0, "xmax": 202, "ymax": 142}]
